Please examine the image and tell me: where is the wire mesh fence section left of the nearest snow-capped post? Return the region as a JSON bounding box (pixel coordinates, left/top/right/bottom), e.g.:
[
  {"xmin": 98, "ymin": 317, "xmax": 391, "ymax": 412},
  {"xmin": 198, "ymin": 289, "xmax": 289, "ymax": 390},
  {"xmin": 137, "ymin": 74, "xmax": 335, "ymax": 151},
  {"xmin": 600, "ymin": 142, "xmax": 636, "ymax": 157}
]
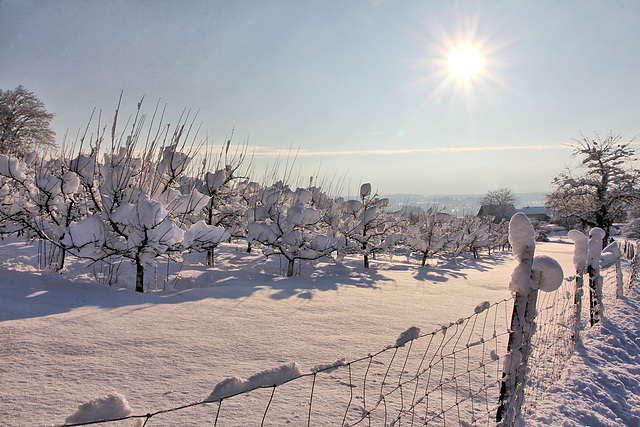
[{"xmin": 57, "ymin": 298, "xmax": 513, "ymax": 426}]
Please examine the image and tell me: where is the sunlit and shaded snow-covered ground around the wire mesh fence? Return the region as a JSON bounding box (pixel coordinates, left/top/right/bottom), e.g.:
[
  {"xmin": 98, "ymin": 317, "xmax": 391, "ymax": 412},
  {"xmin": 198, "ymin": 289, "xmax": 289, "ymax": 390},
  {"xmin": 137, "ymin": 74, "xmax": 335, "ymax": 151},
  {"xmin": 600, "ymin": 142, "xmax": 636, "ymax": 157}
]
[{"xmin": 0, "ymin": 236, "xmax": 640, "ymax": 426}]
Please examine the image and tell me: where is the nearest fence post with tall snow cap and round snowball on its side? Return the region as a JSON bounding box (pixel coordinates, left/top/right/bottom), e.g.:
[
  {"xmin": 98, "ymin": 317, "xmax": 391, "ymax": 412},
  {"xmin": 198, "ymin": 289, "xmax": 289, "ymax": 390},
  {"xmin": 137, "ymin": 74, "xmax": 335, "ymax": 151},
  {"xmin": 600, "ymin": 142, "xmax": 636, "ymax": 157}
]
[{"xmin": 496, "ymin": 213, "xmax": 564, "ymax": 426}]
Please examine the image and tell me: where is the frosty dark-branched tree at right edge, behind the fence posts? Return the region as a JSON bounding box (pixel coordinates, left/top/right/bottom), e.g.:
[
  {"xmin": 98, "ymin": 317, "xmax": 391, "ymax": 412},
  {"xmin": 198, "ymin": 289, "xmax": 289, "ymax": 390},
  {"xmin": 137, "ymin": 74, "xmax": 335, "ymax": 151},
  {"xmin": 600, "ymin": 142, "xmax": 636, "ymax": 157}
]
[{"xmin": 546, "ymin": 133, "xmax": 640, "ymax": 241}]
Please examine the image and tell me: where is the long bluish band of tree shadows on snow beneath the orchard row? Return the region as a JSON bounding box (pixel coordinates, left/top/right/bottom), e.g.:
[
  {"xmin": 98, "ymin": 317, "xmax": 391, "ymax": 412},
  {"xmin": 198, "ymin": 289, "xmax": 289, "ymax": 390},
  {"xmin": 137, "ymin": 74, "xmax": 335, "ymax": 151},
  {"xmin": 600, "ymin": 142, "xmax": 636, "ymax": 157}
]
[{"xmin": 0, "ymin": 247, "xmax": 508, "ymax": 321}]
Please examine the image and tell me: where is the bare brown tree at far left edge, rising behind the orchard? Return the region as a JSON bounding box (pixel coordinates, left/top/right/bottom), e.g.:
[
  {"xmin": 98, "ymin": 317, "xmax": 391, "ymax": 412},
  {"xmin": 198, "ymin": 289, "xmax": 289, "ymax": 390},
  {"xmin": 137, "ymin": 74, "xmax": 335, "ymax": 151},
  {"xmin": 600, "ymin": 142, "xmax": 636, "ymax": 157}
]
[{"xmin": 0, "ymin": 86, "xmax": 55, "ymax": 158}]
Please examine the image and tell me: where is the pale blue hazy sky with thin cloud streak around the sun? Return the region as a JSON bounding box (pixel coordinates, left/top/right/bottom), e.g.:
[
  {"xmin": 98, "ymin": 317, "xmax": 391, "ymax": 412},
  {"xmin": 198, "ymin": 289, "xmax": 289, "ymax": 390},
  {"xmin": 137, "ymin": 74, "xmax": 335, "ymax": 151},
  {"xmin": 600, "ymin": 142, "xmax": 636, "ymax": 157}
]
[{"xmin": 0, "ymin": 0, "xmax": 640, "ymax": 195}]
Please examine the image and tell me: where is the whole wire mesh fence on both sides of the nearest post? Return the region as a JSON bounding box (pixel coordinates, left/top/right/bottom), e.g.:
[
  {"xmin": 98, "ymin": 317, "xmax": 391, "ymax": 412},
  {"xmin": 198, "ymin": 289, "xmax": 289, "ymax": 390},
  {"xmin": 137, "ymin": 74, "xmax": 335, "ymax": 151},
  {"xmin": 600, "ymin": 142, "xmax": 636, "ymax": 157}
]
[{"xmin": 57, "ymin": 236, "xmax": 640, "ymax": 426}]
